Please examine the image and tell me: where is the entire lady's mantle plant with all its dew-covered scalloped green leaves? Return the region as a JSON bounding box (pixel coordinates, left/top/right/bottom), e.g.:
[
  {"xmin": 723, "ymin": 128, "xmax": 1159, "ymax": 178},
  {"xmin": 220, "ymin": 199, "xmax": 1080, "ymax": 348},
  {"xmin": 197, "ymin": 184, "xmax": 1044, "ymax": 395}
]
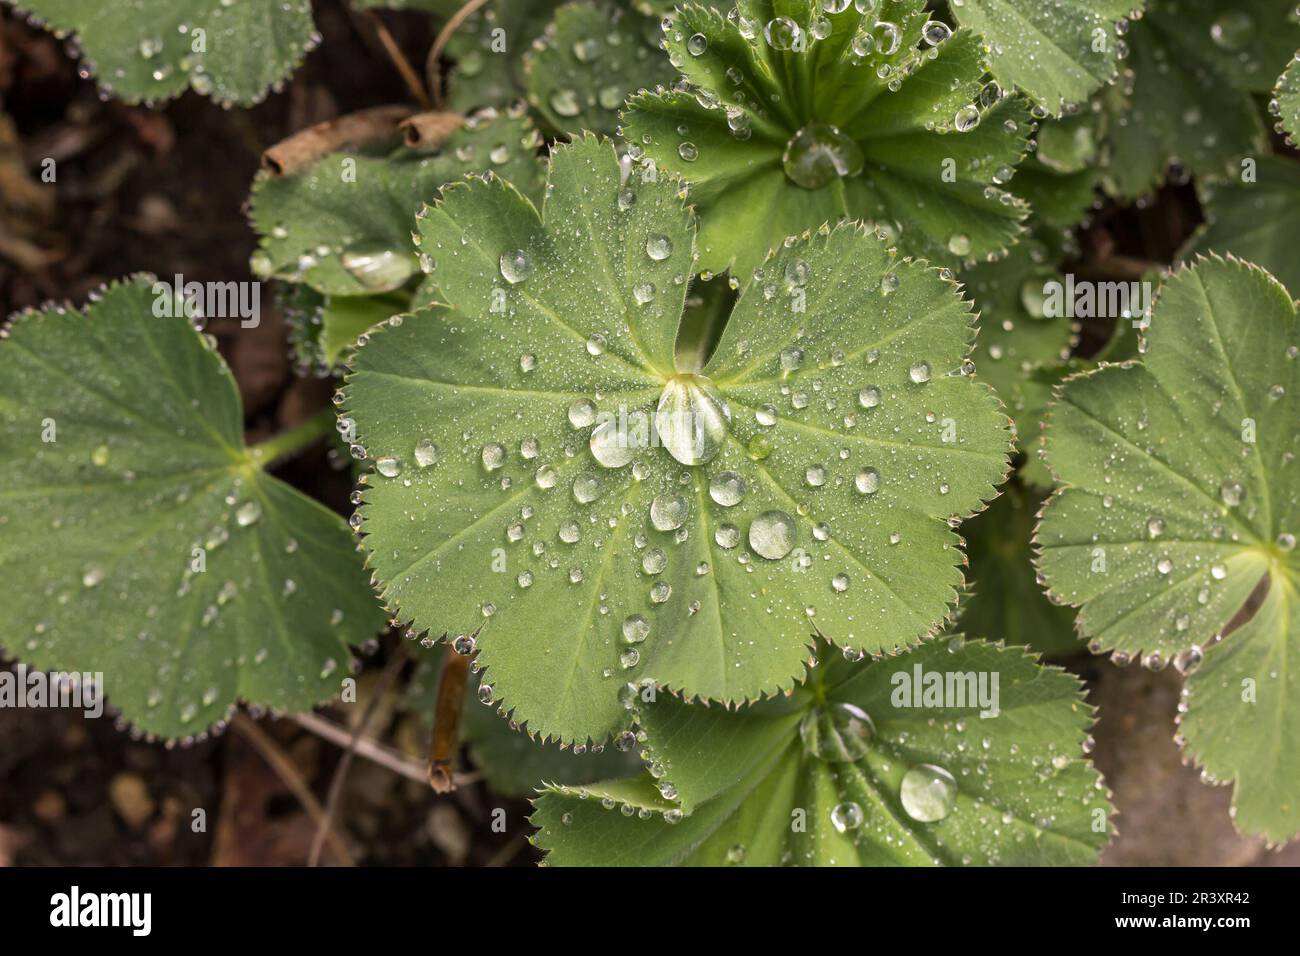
[{"xmin": 0, "ymin": 0, "xmax": 1300, "ymax": 865}]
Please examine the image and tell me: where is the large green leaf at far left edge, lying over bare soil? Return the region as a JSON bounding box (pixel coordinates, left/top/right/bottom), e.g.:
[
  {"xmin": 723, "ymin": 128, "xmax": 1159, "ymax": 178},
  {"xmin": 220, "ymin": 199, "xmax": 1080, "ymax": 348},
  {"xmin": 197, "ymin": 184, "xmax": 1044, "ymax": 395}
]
[{"xmin": 0, "ymin": 280, "xmax": 384, "ymax": 737}]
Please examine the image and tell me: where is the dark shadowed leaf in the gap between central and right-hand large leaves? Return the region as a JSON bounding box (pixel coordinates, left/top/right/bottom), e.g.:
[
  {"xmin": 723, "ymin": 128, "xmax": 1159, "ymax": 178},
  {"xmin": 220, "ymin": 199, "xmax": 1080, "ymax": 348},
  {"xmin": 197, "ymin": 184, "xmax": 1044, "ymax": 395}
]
[{"xmin": 958, "ymin": 483, "xmax": 1083, "ymax": 654}]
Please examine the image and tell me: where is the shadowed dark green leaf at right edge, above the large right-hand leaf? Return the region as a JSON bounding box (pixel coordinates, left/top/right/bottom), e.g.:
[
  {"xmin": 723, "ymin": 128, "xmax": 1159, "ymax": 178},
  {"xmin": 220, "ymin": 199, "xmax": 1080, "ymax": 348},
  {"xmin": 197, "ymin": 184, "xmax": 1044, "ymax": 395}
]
[{"xmin": 1179, "ymin": 156, "xmax": 1300, "ymax": 289}]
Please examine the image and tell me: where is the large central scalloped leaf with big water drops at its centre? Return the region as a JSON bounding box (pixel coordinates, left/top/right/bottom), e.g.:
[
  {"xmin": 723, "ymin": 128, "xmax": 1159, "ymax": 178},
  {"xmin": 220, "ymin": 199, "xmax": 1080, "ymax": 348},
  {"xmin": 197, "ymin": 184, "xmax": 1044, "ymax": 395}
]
[{"xmin": 346, "ymin": 138, "xmax": 1009, "ymax": 741}]
